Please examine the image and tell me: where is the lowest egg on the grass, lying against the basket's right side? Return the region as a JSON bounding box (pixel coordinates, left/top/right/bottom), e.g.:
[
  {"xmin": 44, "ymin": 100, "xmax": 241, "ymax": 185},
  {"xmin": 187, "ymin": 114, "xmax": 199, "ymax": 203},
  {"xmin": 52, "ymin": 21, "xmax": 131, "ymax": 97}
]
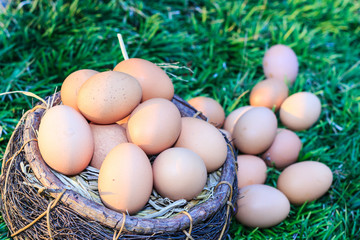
[{"xmin": 235, "ymin": 184, "xmax": 290, "ymax": 228}]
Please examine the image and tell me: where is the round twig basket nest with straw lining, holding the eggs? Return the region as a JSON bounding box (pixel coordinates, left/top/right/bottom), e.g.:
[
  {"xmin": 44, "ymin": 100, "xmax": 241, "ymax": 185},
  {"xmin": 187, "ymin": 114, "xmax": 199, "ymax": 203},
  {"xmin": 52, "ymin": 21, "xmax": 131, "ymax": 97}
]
[{"xmin": 0, "ymin": 93, "xmax": 238, "ymax": 240}]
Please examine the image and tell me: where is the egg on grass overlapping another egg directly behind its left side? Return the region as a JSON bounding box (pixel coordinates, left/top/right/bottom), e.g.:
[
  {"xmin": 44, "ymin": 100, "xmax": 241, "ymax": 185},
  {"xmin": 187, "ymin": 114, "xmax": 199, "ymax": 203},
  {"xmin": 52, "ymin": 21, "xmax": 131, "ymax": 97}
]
[{"xmin": 232, "ymin": 107, "xmax": 277, "ymax": 154}]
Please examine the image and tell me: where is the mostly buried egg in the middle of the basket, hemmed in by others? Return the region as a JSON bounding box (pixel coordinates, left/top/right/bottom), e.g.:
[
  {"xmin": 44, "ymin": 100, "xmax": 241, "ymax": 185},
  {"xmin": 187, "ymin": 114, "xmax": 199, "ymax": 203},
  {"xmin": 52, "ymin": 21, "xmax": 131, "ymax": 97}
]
[{"xmin": 90, "ymin": 123, "xmax": 128, "ymax": 169}]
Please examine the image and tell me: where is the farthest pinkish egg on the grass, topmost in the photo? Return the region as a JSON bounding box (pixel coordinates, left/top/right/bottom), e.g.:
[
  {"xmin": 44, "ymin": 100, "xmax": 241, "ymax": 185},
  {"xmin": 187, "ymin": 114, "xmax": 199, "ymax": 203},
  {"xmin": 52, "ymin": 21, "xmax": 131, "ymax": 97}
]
[{"xmin": 262, "ymin": 44, "xmax": 299, "ymax": 84}]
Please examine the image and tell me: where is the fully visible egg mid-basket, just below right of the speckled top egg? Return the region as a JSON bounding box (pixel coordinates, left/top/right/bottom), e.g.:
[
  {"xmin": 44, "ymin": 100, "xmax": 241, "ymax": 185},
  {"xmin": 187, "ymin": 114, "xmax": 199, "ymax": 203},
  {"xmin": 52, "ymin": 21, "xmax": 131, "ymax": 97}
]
[{"xmin": 126, "ymin": 98, "xmax": 181, "ymax": 154}]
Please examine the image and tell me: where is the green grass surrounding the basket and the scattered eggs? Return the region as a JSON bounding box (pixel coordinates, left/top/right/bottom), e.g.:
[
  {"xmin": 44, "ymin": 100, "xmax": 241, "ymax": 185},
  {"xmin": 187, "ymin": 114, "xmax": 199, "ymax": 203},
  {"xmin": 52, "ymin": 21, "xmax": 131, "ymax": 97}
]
[{"xmin": 0, "ymin": 0, "xmax": 360, "ymax": 239}]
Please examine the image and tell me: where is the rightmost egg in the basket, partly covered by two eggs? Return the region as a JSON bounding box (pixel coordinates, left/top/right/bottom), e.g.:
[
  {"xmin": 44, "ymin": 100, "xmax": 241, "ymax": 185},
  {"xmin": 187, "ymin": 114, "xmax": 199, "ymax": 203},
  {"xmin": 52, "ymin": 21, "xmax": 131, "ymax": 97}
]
[{"xmin": 175, "ymin": 117, "xmax": 227, "ymax": 172}]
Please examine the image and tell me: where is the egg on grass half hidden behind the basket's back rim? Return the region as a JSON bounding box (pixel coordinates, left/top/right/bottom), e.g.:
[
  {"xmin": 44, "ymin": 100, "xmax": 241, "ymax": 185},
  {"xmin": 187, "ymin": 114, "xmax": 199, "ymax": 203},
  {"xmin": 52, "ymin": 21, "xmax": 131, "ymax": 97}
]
[{"xmin": 188, "ymin": 97, "xmax": 225, "ymax": 128}]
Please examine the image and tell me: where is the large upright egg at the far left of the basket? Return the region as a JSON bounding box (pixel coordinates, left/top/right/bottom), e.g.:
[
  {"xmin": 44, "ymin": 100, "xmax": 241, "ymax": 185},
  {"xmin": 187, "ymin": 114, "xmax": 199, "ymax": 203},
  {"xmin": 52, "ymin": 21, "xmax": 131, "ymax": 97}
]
[{"xmin": 38, "ymin": 105, "xmax": 94, "ymax": 175}]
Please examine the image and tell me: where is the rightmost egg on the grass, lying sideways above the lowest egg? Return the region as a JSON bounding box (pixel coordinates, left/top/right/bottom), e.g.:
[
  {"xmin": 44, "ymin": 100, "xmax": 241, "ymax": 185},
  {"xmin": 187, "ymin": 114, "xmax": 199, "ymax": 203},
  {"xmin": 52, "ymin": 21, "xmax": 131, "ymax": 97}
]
[{"xmin": 277, "ymin": 161, "xmax": 333, "ymax": 205}]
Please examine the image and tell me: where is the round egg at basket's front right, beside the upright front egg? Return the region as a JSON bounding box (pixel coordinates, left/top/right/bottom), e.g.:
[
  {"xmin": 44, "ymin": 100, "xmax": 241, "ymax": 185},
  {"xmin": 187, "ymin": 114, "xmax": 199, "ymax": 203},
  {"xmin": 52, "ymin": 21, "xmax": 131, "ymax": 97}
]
[{"xmin": 153, "ymin": 147, "xmax": 207, "ymax": 200}]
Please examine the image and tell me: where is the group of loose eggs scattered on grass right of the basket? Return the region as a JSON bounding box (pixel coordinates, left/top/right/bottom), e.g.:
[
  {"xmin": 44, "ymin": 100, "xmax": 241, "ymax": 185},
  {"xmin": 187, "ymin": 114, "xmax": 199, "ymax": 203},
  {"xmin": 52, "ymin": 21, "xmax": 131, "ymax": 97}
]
[{"xmin": 189, "ymin": 44, "xmax": 333, "ymax": 228}]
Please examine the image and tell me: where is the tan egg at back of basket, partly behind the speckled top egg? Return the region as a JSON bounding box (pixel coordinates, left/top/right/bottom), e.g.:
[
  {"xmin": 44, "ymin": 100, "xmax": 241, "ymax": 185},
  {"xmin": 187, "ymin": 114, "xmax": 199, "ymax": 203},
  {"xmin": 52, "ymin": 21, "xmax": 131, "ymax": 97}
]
[{"xmin": 114, "ymin": 58, "xmax": 174, "ymax": 102}]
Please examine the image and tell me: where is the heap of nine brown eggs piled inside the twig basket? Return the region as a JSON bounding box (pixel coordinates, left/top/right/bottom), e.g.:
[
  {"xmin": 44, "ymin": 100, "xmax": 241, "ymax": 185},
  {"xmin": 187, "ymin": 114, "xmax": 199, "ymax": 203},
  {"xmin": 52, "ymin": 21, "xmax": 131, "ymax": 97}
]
[{"xmin": 38, "ymin": 58, "xmax": 228, "ymax": 214}]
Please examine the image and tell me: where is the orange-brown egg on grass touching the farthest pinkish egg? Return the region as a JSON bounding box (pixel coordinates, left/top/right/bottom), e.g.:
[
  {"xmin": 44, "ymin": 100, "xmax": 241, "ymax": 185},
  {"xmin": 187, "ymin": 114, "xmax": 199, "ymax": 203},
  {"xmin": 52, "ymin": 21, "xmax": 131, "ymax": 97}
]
[{"xmin": 250, "ymin": 78, "xmax": 289, "ymax": 111}]
